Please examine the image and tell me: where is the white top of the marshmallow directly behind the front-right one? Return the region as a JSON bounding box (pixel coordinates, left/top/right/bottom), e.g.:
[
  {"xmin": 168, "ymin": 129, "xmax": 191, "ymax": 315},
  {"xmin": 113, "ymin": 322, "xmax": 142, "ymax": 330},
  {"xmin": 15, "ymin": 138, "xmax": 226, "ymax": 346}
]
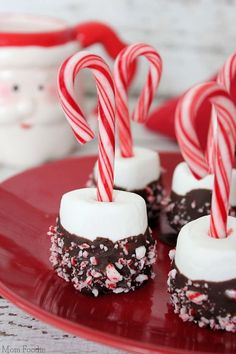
[{"xmin": 172, "ymin": 162, "xmax": 236, "ymax": 206}]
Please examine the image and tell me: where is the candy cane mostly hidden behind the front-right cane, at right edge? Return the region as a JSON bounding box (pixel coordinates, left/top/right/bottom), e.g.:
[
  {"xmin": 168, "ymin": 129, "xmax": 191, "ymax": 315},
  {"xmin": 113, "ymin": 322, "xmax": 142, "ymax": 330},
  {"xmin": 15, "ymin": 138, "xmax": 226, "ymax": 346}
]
[{"xmin": 206, "ymin": 53, "xmax": 236, "ymax": 169}]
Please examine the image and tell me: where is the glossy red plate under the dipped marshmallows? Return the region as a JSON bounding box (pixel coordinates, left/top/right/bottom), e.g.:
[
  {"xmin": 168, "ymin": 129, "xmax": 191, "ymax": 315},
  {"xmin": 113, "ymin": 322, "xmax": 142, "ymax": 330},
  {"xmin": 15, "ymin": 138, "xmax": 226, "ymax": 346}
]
[{"xmin": 0, "ymin": 153, "xmax": 236, "ymax": 353}]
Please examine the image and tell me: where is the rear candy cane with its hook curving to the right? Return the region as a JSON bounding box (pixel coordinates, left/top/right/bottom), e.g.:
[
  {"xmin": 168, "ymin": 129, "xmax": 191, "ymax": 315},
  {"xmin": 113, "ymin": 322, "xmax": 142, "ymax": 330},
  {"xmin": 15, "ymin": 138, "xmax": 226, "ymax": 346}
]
[{"xmin": 114, "ymin": 43, "xmax": 162, "ymax": 157}]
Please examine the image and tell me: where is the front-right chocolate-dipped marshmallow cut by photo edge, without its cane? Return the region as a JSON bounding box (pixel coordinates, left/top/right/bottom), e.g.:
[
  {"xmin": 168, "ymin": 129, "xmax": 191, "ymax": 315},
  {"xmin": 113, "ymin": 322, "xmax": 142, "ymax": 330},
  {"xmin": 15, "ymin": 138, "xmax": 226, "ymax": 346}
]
[{"xmin": 168, "ymin": 215, "xmax": 236, "ymax": 332}]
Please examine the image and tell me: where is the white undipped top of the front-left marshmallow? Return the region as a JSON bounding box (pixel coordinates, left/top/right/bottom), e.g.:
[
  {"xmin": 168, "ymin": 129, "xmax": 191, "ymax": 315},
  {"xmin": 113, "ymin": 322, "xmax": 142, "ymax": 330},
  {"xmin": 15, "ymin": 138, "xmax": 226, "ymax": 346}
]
[{"xmin": 59, "ymin": 188, "xmax": 148, "ymax": 242}]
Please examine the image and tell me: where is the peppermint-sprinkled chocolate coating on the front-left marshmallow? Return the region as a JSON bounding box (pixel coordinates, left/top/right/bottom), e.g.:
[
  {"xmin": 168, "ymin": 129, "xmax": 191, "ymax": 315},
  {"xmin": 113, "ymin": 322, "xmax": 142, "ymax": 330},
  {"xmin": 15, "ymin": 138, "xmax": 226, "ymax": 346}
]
[{"xmin": 48, "ymin": 221, "xmax": 156, "ymax": 296}]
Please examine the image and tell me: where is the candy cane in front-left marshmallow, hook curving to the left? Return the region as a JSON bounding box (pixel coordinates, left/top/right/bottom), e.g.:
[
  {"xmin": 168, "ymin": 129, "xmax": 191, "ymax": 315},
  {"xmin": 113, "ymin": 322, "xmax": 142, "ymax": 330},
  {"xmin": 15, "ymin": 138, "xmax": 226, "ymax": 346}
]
[{"xmin": 58, "ymin": 51, "xmax": 115, "ymax": 202}]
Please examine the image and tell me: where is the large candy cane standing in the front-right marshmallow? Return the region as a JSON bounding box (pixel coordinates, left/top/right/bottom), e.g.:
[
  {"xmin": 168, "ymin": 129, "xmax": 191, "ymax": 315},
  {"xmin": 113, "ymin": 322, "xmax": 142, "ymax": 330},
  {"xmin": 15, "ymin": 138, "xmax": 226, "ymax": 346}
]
[{"xmin": 176, "ymin": 82, "xmax": 236, "ymax": 238}]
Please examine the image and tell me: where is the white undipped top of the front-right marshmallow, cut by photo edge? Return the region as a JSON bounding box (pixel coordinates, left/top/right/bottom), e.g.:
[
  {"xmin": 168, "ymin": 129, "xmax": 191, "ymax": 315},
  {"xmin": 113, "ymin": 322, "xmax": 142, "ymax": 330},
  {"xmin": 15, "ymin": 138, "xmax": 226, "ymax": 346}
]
[{"xmin": 175, "ymin": 215, "xmax": 236, "ymax": 281}]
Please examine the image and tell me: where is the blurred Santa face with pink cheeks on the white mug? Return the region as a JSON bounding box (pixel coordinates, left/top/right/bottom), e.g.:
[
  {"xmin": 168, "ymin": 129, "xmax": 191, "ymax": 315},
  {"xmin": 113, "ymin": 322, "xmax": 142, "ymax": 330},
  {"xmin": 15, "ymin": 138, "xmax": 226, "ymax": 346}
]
[{"xmin": 0, "ymin": 69, "xmax": 64, "ymax": 129}]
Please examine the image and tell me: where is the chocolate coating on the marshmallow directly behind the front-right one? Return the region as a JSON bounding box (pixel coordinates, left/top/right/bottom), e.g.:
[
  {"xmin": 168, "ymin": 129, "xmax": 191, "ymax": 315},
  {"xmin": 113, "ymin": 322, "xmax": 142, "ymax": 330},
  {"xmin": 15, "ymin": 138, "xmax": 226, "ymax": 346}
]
[{"xmin": 165, "ymin": 189, "xmax": 236, "ymax": 232}]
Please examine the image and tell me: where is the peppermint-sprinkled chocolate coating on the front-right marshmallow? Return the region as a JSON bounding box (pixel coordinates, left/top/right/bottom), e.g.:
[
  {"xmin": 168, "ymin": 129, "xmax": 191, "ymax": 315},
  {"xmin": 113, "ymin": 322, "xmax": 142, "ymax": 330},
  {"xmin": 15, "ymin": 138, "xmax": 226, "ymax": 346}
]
[{"xmin": 168, "ymin": 264, "xmax": 236, "ymax": 332}]
